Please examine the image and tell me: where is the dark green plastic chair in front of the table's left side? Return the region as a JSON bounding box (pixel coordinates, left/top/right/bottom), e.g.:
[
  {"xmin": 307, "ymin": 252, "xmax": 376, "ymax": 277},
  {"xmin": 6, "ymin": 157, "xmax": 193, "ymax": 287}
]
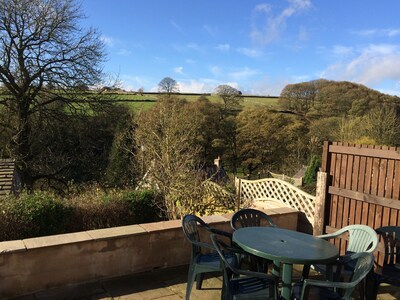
[{"xmin": 211, "ymin": 234, "xmax": 278, "ymax": 300}]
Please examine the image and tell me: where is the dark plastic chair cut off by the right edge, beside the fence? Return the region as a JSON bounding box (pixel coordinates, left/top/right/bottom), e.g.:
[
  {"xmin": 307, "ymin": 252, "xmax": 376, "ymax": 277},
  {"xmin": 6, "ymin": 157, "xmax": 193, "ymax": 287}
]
[{"xmin": 368, "ymin": 226, "xmax": 400, "ymax": 299}]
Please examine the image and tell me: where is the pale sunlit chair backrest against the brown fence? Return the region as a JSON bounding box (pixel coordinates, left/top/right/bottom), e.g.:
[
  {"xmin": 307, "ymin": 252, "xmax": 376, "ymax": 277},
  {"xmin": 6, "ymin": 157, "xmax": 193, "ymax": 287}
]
[{"xmin": 335, "ymin": 224, "xmax": 379, "ymax": 253}]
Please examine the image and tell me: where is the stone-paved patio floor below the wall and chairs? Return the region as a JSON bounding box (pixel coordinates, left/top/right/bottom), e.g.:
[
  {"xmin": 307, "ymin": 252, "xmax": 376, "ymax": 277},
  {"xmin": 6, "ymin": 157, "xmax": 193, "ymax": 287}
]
[{"xmin": 12, "ymin": 265, "xmax": 400, "ymax": 300}]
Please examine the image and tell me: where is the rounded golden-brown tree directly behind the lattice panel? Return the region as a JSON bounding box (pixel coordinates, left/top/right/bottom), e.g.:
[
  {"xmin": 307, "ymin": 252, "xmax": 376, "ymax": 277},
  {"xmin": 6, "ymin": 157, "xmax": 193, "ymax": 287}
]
[{"xmin": 238, "ymin": 109, "xmax": 307, "ymax": 174}]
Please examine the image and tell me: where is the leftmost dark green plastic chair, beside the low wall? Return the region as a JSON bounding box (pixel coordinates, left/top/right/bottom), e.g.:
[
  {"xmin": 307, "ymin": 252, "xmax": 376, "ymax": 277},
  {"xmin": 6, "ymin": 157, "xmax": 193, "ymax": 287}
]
[{"xmin": 182, "ymin": 215, "xmax": 236, "ymax": 300}]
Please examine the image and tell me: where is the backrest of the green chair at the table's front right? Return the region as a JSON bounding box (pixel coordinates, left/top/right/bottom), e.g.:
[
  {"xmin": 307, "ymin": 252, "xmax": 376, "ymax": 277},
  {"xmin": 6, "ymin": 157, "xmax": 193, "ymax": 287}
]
[{"xmin": 343, "ymin": 252, "xmax": 374, "ymax": 299}]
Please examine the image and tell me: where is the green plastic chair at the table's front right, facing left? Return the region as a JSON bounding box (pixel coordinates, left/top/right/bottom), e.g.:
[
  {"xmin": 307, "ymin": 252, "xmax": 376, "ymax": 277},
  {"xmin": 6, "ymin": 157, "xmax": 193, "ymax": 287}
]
[{"xmin": 292, "ymin": 252, "xmax": 374, "ymax": 300}]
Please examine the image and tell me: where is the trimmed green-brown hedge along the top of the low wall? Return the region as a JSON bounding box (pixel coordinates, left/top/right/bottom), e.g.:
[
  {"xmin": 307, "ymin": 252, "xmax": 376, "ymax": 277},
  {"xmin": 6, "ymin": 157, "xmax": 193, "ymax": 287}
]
[{"xmin": 0, "ymin": 187, "xmax": 160, "ymax": 241}]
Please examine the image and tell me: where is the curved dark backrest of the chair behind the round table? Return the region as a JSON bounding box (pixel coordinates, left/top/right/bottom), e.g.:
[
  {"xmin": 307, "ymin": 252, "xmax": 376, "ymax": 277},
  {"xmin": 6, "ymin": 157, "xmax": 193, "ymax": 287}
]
[{"xmin": 231, "ymin": 208, "xmax": 276, "ymax": 230}]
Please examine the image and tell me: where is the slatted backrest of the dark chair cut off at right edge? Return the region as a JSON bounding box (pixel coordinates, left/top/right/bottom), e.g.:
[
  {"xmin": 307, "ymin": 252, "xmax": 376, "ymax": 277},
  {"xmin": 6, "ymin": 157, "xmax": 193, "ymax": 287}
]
[{"xmin": 376, "ymin": 226, "xmax": 400, "ymax": 273}]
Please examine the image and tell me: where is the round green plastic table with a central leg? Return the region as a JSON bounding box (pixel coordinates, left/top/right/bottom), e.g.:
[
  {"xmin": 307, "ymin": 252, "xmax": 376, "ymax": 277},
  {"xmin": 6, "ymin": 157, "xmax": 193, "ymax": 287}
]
[{"xmin": 232, "ymin": 227, "xmax": 339, "ymax": 300}]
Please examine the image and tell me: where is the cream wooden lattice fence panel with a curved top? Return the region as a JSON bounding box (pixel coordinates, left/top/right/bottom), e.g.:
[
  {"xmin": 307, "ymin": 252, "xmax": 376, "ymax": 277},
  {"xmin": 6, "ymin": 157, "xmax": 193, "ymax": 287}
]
[{"xmin": 235, "ymin": 178, "xmax": 315, "ymax": 224}]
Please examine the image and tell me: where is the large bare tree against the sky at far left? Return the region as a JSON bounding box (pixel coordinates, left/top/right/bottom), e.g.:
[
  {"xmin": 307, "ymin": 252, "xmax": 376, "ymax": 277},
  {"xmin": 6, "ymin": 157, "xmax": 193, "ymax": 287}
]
[{"xmin": 0, "ymin": 0, "xmax": 104, "ymax": 187}]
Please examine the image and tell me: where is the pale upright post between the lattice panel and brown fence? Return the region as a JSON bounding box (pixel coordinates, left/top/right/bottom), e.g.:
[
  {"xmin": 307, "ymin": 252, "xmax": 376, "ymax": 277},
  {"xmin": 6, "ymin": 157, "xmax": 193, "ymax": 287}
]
[{"xmin": 313, "ymin": 172, "xmax": 328, "ymax": 235}]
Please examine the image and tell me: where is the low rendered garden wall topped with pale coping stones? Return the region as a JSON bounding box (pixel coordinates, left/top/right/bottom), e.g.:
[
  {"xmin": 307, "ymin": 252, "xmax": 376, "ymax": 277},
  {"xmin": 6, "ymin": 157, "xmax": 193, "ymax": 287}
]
[{"xmin": 0, "ymin": 208, "xmax": 298, "ymax": 299}]
